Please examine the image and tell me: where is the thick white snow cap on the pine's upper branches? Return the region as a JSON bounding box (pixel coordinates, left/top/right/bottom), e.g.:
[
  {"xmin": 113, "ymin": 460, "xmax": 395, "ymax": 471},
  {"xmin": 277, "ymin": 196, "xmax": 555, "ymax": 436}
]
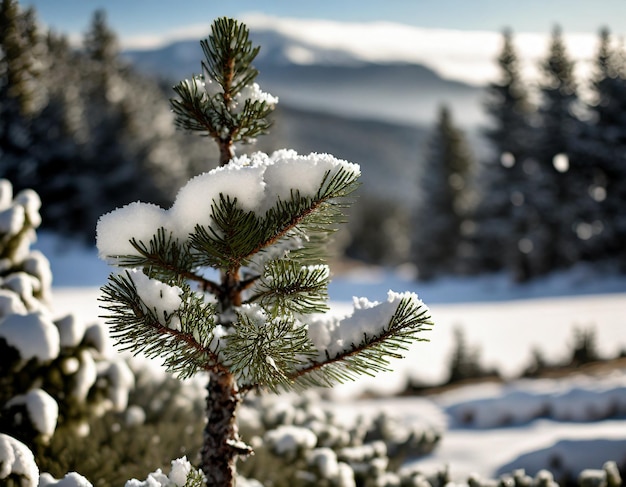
[{"xmin": 96, "ymin": 150, "xmax": 361, "ymax": 259}]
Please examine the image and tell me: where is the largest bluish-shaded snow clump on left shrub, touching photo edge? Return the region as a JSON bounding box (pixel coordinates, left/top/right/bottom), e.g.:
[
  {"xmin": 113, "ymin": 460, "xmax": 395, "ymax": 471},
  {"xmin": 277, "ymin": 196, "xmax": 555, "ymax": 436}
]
[{"xmin": 0, "ymin": 313, "xmax": 61, "ymax": 362}]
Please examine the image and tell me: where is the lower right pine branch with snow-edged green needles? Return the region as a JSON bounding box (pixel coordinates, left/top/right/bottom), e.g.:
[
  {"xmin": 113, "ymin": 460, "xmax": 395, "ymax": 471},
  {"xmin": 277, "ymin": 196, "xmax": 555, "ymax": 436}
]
[{"xmin": 289, "ymin": 297, "xmax": 433, "ymax": 388}]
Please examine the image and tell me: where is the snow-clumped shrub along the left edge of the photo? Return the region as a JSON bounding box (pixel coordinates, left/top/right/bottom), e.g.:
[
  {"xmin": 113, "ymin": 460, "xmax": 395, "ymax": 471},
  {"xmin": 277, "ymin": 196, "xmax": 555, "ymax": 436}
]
[{"xmin": 0, "ymin": 180, "xmax": 134, "ymax": 474}]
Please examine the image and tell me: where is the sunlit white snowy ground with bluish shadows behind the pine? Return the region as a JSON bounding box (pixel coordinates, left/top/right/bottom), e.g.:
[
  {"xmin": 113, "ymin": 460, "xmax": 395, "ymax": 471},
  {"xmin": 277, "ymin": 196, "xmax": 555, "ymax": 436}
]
[{"xmin": 38, "ymin": 236, "xmax": 626, "ymax": 479}]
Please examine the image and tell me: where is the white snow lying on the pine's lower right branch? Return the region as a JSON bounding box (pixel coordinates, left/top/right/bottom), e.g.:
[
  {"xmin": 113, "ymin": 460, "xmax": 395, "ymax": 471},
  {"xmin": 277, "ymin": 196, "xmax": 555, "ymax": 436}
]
[{"xmin": 308, "ymin": 291, "xmax": 428, "ymax": 357}]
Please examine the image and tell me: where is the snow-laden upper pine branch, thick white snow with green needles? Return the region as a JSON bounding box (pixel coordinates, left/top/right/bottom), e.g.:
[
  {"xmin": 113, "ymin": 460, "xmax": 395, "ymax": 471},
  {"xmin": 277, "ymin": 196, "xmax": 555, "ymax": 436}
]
[{"xmin": 97, "ymin": 150, "xmax": 360, "ymax": 266}]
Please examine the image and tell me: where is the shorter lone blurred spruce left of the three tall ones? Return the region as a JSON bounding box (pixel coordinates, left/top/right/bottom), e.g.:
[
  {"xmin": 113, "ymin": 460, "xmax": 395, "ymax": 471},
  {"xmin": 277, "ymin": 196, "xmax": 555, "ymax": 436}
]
[{"xmin": 413, "ymin": 106, "xmax": 474, "ymax": 279}]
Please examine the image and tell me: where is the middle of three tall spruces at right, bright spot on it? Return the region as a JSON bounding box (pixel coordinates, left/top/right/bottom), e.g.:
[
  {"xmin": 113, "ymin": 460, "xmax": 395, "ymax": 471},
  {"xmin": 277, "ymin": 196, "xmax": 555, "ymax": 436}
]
[{"xmin": 528, "ymin": 27, "xmax": 587, "ymax": 275}]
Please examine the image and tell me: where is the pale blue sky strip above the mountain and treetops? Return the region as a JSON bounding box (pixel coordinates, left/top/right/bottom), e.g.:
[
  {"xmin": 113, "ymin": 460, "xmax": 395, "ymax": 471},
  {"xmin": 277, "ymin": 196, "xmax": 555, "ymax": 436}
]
[{"xmin": 20, "ymin": 0, "xmax": 626, "ymax": 48}]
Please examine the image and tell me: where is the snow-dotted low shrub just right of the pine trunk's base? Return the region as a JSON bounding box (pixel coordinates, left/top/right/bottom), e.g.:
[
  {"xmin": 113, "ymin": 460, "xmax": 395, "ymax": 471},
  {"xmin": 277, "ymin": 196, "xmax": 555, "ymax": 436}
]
[{"xmin": 233, "ymin": 394, "xmax": 441, "ymax": 487}]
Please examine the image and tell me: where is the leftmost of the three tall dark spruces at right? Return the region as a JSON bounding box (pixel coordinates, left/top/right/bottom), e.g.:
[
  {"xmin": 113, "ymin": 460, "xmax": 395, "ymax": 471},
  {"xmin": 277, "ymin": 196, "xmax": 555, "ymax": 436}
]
[{"xmin": 474, "ymin": 30, "xmax": 537, "ymax": 281}]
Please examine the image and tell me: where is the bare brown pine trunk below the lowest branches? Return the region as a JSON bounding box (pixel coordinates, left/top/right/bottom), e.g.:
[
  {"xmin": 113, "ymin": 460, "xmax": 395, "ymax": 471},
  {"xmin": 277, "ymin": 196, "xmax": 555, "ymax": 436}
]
[{"xmin": 201, "ymin": 373, "xmax": 241, "ymax": 487}]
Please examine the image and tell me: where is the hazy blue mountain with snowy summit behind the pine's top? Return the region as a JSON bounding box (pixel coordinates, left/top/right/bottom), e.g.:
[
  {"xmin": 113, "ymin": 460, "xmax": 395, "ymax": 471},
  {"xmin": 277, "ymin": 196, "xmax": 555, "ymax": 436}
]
[{"xmin": 125, "ymin": 26, "xmax": 484, "ymax": 126}]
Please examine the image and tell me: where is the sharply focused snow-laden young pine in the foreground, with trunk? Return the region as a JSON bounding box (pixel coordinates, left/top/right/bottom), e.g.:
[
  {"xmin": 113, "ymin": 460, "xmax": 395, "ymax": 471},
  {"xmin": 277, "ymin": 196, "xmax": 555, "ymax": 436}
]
[{"xmin": 97, "ymin": 18, "xmax": 432, "ymax": 486}]
